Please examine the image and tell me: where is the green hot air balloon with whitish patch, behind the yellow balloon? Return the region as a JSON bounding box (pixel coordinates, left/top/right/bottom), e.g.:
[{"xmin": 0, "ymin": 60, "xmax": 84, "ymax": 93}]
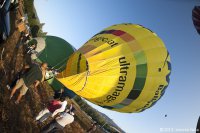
[{"xmin": 31, "ymin": 36, "xmax": 75, "ymax": 92}]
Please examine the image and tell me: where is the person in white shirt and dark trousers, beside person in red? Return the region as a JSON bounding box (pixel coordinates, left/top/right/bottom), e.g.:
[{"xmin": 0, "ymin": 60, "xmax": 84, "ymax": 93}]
[{"xmin": 42, "ymin": 105, "xmax": 75, "ymax": 133}]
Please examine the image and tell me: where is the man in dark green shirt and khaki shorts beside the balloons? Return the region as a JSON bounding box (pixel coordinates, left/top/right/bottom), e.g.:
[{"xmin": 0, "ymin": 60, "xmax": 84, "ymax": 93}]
[{"xmin": 10, "ymin": 63, "xmax": 48, "ymax": 104}]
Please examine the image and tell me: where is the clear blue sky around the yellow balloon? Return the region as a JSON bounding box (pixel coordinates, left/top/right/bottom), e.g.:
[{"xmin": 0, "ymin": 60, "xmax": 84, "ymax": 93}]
[{"xmin": 35, "ymin": 0, "xmax": 200, "ymax": 133}]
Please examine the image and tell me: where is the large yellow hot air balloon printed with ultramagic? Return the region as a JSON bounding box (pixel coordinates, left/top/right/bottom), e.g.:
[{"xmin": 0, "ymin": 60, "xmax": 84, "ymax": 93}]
[{"xmin": 57, "ymin": 24, "xmax": 171, "ymax": 113}]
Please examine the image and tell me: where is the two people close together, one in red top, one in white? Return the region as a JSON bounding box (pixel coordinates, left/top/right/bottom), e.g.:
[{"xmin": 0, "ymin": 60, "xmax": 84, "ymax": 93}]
[{"xmin": 35, "ymin": 98, "xmax": 75, "ymax": 133}]
